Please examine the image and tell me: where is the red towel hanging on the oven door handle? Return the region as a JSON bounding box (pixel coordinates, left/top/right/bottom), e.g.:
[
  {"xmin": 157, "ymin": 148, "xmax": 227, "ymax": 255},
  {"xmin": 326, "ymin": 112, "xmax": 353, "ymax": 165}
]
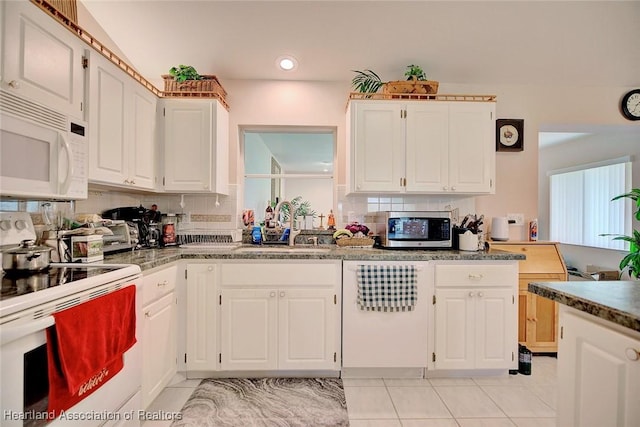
[{"xmin": 47, "ymin": 286, "xmax": 136, "ymax": 418}]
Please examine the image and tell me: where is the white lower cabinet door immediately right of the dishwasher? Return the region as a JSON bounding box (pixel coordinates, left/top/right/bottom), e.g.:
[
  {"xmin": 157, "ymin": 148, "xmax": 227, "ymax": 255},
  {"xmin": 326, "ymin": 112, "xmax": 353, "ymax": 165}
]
[{"xmin": 435, "ymin": 289, "xmax": 476, "ymax": 369}]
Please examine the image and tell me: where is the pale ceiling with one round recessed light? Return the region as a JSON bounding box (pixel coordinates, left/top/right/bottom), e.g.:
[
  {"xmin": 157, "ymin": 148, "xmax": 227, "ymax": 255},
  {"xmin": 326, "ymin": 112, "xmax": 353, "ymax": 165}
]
[{"xmin": 79, "ymin": 0, "xmax": 640, "ymax": 87}]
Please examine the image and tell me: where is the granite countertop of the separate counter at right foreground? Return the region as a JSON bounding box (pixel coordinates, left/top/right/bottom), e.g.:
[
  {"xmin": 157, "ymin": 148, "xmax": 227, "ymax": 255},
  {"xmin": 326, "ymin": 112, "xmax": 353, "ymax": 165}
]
[{"xmin": 529, "ymin": 280, "xmax": 640, "ymax": 332}]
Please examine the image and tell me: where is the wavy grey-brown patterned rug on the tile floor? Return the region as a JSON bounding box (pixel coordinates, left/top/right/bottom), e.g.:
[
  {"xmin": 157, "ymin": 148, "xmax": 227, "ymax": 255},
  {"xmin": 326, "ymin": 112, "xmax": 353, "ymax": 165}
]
[{"xmin": 171, "ymin": 378, "xmax": 349, "ymax": 427}]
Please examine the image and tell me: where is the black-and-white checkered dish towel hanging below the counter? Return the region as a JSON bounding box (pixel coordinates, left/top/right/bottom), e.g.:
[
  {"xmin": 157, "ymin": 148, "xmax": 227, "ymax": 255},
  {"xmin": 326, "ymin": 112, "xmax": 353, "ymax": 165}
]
[{"xmin": 357, "ymin": 265, "xmax": 418, "ymax": 311}]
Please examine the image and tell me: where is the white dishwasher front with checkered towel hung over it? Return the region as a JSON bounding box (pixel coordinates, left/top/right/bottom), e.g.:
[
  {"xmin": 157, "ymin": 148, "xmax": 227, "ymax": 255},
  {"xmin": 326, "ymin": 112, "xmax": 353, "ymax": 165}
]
[{"xmin": 342, "ymin": 261, "xmax": 434, "ymax": 368}]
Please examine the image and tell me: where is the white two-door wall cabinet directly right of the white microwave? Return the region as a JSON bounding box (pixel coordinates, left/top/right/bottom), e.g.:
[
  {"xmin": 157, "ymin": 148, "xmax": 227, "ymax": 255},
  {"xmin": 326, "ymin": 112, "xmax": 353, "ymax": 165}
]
[{"xmin": 89, "ymin": 53, "xmax": 157, "ymax": 190}]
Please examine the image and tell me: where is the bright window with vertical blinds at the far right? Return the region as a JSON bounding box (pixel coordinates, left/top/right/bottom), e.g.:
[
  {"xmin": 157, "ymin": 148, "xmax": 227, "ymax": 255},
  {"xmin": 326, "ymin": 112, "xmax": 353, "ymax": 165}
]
[{"xmin": 549, "ymin": 158, "xmax": 631, "ymax": 250}]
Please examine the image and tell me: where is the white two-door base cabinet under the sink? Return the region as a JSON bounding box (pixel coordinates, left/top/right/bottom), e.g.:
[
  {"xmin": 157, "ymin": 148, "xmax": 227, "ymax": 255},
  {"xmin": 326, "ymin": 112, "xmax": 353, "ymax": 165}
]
[{"xmin": 219, "ymin": 260, "xmax": 341, "ymax": 371}]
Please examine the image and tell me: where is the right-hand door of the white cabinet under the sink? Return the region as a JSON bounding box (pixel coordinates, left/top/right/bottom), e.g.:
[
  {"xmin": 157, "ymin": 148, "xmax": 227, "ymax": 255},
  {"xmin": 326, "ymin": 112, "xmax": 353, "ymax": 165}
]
[{"xmin": 278, "ymin": 289, "xmax": 339, "ymax": 369}]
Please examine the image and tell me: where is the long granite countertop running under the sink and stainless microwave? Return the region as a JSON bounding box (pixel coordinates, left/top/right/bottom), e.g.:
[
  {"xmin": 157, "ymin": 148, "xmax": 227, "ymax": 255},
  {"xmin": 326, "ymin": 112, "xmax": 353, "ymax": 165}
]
[{"xmin": 103, "ymin": 245, "xmax": 525, "ymax": 271}]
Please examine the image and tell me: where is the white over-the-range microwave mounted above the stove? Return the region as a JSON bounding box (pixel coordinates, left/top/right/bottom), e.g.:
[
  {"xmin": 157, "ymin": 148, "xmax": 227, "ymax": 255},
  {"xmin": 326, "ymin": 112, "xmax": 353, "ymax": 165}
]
[{"xmin": 0, "ymin": 90, "xmax": 89, "ymax": 200}]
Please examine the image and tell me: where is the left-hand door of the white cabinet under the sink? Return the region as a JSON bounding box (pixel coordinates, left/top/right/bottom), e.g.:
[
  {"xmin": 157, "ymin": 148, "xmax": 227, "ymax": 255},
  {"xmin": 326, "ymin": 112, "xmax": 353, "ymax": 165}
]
[{"xmin": 220, "ymin": 289, "xmax": 278, "ymax": 371}]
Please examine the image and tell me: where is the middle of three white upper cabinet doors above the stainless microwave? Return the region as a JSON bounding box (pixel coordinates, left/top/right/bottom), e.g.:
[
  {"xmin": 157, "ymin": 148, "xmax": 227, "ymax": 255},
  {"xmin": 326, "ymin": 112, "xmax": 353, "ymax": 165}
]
[{"xmin": 406, "ymin": 102, "xmax": 449, "ymax": 193}]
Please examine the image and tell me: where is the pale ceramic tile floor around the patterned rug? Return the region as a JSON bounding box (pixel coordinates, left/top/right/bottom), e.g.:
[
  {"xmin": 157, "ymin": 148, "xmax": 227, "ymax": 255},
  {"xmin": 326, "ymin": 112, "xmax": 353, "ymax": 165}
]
[{"xmin": 142, "ymin": 356, "xmax": 556, "ymax": 427}]
